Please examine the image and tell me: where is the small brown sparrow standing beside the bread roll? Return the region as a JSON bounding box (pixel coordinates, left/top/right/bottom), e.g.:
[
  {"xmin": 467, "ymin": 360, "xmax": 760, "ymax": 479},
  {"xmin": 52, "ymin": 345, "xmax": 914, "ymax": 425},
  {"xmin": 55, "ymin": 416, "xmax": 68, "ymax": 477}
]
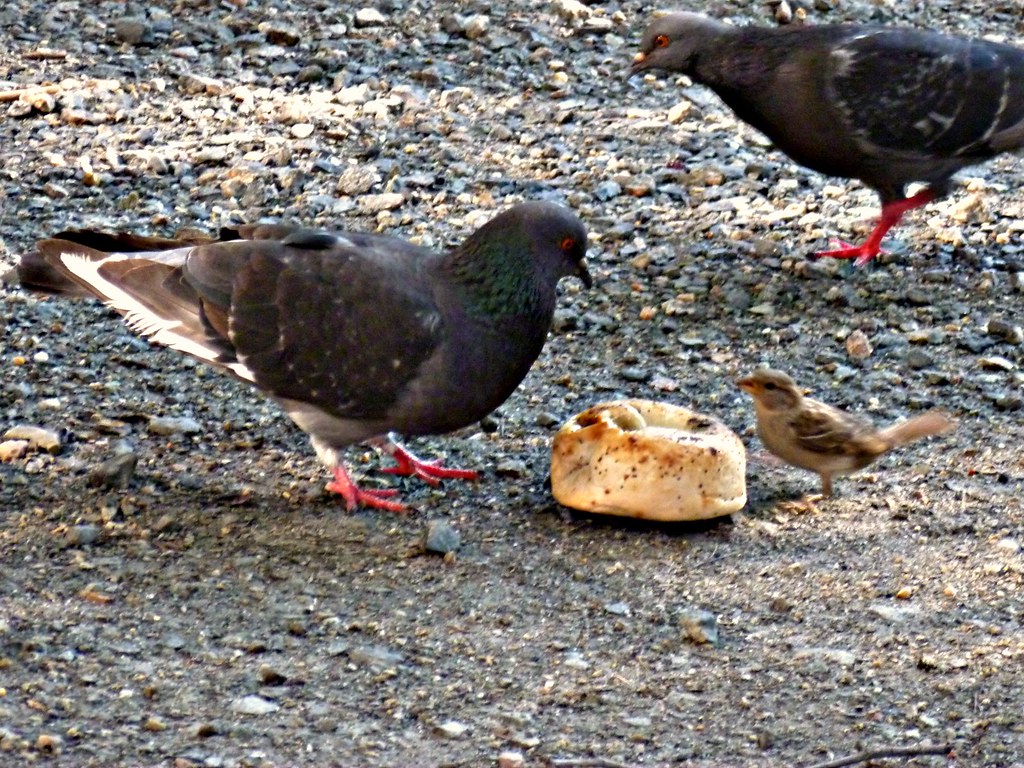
[{"xmin": 736, "ymin": 369, "xmax": 954, "ymax": 496}]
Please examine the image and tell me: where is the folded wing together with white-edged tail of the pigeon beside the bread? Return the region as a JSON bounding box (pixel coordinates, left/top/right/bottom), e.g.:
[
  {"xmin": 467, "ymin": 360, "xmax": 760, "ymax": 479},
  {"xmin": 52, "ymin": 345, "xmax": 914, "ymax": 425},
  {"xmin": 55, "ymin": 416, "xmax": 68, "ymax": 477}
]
[{"xmin": 36, "ymin": 229, "xmax": 441, "ymax": 419}]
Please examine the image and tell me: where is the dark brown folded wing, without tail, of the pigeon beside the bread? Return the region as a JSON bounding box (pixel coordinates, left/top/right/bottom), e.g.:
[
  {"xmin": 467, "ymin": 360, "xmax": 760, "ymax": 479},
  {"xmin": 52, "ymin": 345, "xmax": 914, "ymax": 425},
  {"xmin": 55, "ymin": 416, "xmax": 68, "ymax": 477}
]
[{"xmin": 182, "ymin": 230, "xmax": 441, "ymax": 420}]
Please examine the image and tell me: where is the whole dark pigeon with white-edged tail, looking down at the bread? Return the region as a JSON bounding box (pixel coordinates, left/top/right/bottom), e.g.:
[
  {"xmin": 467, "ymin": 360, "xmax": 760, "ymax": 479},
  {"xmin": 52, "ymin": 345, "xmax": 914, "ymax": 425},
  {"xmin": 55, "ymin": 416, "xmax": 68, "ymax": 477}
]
[{"xmin": 18, "ymin": 202, "xmax": 591, "ymax": 511}]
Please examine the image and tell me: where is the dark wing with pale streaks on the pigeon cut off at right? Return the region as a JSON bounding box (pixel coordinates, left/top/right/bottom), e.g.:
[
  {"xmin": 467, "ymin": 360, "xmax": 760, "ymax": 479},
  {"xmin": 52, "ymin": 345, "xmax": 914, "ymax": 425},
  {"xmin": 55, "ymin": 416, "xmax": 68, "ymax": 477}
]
[{"xmin": 826, "ymin": 28, "xmax": 1024, "ymax": 158}]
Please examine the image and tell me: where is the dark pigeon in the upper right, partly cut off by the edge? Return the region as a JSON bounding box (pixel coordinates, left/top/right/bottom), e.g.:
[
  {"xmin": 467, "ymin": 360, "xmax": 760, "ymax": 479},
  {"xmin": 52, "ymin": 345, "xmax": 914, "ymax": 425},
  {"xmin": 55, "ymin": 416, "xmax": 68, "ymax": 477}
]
[{"xmin": 631, "ymin": 13, "xmax": 1024, "ymax": 265}]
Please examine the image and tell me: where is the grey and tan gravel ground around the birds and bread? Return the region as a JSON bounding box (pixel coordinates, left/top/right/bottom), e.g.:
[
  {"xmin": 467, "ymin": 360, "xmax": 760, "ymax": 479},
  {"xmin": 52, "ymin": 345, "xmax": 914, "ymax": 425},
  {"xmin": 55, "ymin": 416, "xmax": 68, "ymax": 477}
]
[{"xmin": 0, "ymin": 0, "xmax": 1024, "ymax": 768}]
